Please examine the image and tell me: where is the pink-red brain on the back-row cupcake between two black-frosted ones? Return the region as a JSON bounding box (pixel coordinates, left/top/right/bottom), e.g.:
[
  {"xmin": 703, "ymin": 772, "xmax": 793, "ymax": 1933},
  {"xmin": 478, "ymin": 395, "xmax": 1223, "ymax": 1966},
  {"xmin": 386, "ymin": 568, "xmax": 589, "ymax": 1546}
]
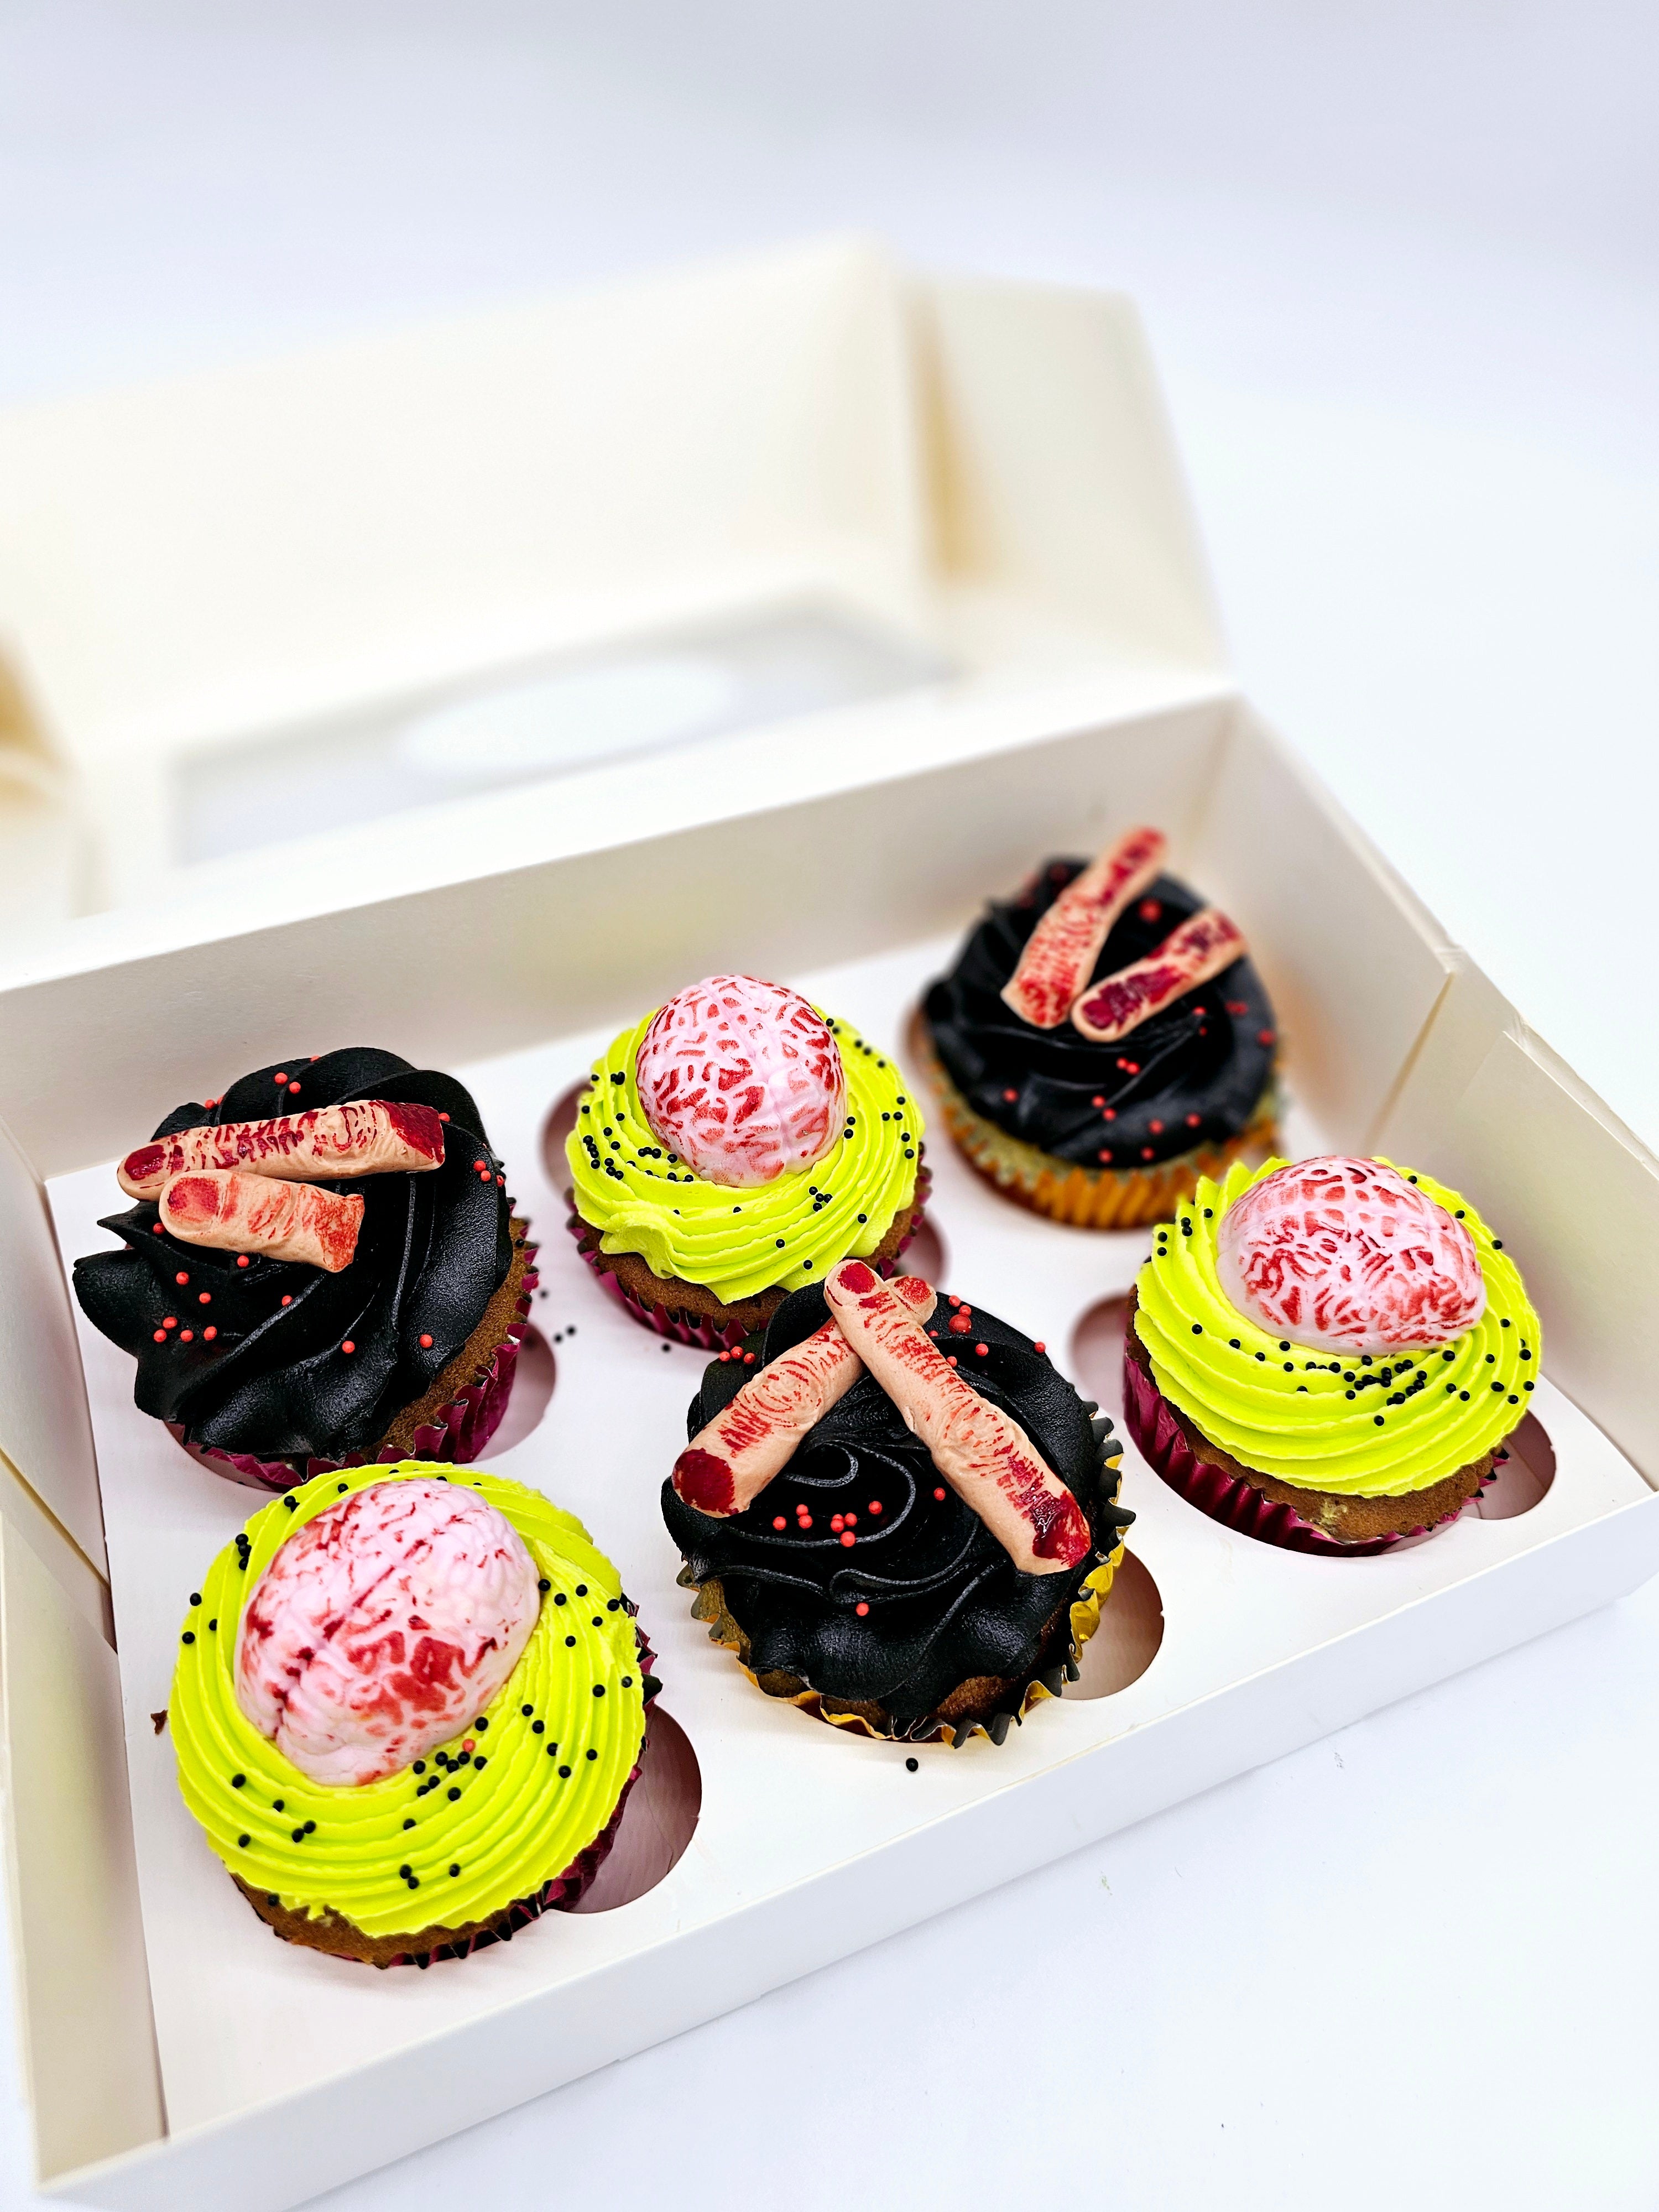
[{"xmin": 635, "ymin": 975, "xmax": 847, "ymax": 1190}]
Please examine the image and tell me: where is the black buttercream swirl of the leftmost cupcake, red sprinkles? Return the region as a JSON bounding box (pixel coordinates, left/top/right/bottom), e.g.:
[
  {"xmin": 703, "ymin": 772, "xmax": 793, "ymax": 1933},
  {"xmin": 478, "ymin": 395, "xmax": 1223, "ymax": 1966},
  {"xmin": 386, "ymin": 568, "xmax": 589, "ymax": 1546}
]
[{"xmin": 75, "ymin": 1046, "xmax": 513, "ymax": 1460}]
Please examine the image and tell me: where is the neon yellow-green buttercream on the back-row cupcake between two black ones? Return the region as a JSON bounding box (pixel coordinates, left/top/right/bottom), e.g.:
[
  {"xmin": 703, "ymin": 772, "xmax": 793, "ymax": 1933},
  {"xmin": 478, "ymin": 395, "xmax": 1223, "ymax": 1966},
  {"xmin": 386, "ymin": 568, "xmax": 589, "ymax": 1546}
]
[{"xmin": 564, "ymin": 1009, "xmax": 922, "ymax": 1305}]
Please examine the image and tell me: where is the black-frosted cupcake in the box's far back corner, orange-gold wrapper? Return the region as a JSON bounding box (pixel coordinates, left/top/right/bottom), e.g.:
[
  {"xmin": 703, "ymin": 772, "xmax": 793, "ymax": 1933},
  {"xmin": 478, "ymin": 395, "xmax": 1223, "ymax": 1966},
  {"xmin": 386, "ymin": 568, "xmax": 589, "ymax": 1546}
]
[{"xmin": 920, "ymin": 830, "xmax": 1279, "ymax": 1230}]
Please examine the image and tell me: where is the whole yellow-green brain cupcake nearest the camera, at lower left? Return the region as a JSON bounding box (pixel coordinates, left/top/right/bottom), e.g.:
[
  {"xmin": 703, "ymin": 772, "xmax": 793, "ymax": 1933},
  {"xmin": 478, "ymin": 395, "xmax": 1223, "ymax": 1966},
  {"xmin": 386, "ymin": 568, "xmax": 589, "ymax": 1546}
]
[{"xmin": 168, "ymin": 1462, "xmax": 657, "ymax": 1966}]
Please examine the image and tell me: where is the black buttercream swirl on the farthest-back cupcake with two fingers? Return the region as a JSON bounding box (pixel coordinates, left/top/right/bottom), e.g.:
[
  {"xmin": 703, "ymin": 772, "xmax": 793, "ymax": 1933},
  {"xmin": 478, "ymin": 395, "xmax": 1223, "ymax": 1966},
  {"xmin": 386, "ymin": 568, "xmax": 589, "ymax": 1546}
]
[{"xmin": 925, "ymin": 860, "xmax": 1274, "ymax": 1168}]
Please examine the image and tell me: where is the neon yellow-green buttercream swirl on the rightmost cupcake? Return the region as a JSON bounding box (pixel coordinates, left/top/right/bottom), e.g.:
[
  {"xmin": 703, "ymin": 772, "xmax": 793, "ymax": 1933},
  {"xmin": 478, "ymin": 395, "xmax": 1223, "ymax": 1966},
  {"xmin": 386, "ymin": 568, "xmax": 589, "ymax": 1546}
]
[{"xmin": 1135, "ymin": 1159, "xmax": 1542, "ymax": 1498}]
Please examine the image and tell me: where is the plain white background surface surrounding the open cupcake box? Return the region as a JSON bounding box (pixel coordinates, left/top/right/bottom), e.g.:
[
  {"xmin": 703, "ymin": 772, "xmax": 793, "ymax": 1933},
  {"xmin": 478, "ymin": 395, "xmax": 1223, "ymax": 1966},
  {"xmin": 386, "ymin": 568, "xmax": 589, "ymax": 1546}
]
[{"xmin": 0, "ymin": 0, "xmax": 1659, "ymax": 2212}]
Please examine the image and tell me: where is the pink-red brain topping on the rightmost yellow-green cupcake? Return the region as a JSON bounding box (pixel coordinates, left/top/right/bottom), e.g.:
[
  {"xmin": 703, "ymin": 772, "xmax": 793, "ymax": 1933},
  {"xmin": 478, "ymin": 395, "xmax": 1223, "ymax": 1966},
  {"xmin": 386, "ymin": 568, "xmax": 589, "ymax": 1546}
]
[{"xmin": 1217, "ymin": 1157, "xmax": 1486, "ymax": 1354}]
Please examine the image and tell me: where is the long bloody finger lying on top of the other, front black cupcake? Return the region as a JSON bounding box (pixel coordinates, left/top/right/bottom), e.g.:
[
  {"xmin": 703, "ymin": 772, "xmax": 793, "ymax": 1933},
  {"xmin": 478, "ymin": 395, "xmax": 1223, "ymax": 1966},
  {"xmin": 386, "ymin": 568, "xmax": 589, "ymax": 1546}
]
[{"xmin": 823, "ymin": 1259, "xmax": 1093, "ymax": 1575}]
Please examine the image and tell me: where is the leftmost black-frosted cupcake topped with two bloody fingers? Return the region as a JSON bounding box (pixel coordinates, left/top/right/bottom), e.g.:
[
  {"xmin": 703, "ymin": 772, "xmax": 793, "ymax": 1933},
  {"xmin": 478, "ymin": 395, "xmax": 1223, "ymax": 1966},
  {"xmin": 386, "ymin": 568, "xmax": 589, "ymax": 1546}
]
[{"xmin": 75, "ymin": 1048, "xmax": 535, "ymax": 1489}]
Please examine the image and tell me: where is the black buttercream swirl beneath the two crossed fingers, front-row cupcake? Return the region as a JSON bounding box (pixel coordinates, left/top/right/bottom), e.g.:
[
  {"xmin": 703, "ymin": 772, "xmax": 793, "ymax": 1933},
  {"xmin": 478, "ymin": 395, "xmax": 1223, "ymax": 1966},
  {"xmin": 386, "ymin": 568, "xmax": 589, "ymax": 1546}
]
[{"xmin": 661, "ymin": 1285, "xmax": 1133, "ymax": 1736}]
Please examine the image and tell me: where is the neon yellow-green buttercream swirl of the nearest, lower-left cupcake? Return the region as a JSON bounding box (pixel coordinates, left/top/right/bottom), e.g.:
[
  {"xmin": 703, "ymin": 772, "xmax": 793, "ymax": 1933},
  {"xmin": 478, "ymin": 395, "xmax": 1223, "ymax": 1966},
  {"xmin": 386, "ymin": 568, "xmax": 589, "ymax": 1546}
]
[{"xmin": 168, "ymin": 1460, "xmax": 646, "ymax": 1936}]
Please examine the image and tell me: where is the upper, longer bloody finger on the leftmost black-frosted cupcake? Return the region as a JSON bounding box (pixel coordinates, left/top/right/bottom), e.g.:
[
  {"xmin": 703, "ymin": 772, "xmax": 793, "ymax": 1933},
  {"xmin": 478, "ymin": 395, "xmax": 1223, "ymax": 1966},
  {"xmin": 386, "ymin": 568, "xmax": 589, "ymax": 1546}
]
[{"xmin": 115, "ymin": 1099, "xmax": 445, "ymax": 1199}]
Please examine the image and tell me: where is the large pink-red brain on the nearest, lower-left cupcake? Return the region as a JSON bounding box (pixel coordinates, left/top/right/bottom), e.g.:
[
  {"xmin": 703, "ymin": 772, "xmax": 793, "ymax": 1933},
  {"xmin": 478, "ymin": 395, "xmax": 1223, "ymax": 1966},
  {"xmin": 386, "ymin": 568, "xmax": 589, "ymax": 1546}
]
[{"xmin": 237, "ymin": 1478, "xmax": 542, "ymax": 1783}]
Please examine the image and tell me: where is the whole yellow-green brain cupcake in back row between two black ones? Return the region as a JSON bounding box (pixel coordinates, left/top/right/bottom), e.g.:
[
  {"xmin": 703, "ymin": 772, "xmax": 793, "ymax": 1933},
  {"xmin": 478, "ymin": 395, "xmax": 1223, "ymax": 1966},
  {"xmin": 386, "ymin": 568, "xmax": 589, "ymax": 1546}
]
[{"xmin": 564, "ymin": 975, "xmax": 927, "ymax": 1352}]
